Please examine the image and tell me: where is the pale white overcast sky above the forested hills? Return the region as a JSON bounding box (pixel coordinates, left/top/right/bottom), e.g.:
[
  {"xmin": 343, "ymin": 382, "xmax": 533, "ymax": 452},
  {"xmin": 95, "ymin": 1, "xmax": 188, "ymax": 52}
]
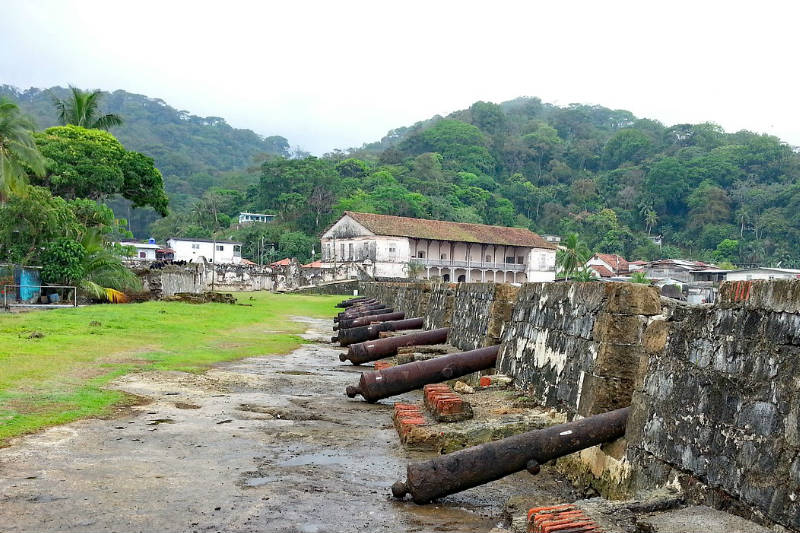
[{"xmin": 0, "ymin": 0, "xmax": 800, "ymax": 154}]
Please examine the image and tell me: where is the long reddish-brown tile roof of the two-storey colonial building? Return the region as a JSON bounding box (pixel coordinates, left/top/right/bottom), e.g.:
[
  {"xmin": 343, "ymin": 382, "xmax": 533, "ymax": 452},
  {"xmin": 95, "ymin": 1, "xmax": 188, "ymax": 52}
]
[{"xmin": 344, "ymin": 211, "xmax": 556, "ymax": 250}]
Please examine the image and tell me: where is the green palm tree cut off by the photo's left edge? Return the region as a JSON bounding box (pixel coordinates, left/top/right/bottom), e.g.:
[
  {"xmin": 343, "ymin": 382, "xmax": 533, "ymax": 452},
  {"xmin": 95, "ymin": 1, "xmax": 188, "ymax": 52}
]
[{"xmin": 0, "ymin": 98, "xmax": 44, "ymax": 202}]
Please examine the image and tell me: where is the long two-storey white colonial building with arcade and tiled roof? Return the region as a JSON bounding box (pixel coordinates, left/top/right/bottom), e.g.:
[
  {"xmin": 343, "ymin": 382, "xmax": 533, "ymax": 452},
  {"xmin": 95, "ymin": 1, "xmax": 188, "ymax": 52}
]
[{"xmin": 321, "ymin": 211, "xmax": 556, "ymax": 283}]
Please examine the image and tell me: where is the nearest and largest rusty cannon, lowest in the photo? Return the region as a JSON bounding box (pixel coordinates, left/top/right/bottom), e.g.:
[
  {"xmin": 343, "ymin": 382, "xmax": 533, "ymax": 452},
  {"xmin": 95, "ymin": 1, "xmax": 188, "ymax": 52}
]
[{"xmin": 392, "ymin": 407, "xmax": 630, "ymax": 503}]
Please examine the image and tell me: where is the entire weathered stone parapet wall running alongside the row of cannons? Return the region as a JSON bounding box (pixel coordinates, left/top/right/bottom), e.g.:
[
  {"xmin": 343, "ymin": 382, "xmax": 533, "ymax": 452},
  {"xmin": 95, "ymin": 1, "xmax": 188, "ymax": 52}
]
[{"xmin": 361, "ymin": 281, "xmax": 800, "ymax": 529}]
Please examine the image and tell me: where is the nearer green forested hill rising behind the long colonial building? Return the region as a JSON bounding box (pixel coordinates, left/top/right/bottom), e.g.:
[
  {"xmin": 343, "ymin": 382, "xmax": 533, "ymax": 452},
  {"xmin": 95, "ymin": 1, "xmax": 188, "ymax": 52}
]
[{"xmin": 203, "ymin": 98, "xmax": 800, "ymax": 266}]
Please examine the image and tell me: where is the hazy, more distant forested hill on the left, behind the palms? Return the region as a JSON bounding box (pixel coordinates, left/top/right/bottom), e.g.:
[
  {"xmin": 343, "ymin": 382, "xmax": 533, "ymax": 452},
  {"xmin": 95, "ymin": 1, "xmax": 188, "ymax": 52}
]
[{"xmin": 0, "ymin": 85, "xmax": 290, "ymax": 230}]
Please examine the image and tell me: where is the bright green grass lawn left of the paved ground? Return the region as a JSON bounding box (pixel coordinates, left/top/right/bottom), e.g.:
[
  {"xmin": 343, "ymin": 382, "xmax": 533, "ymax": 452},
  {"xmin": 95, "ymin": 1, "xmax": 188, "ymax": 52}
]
[{"xmin": 0, "ymin": 292, "xmax": 342, "ymax": 446}]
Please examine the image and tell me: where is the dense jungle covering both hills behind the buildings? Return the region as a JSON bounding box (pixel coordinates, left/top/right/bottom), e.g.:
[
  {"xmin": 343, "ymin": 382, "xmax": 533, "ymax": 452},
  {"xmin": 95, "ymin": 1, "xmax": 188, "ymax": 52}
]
[{"xmin": 0, "ymin": 91, "xmax": 800, "ymax": 267}]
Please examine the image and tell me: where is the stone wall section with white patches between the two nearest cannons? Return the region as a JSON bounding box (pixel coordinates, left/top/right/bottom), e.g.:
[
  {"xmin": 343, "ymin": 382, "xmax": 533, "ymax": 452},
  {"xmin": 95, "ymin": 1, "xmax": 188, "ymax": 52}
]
[{"xmin": 498, "ymin": 283, "xmax": 661, "ymax": 416}]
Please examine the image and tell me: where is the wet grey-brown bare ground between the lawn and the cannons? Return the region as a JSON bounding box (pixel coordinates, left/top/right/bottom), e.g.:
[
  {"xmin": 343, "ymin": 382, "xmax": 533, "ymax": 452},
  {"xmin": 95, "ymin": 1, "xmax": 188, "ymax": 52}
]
[{"xmin": 0, "ymin": 320, "xmax": 568, "ymax": 533}]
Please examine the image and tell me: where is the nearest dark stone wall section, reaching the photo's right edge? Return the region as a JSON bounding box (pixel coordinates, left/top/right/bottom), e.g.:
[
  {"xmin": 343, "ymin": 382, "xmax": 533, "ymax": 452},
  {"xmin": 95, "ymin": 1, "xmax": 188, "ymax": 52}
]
[{"xmin": 627, "ymin": 281, "xmax": 800, "ymax": 529}]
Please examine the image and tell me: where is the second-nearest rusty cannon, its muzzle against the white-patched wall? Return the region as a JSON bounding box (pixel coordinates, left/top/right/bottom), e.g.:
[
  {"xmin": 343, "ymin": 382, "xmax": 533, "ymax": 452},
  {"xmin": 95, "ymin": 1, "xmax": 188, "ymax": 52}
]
[{"xmin": 347, "ymin": 346, "xmax": 500, "ymax": 403}]
